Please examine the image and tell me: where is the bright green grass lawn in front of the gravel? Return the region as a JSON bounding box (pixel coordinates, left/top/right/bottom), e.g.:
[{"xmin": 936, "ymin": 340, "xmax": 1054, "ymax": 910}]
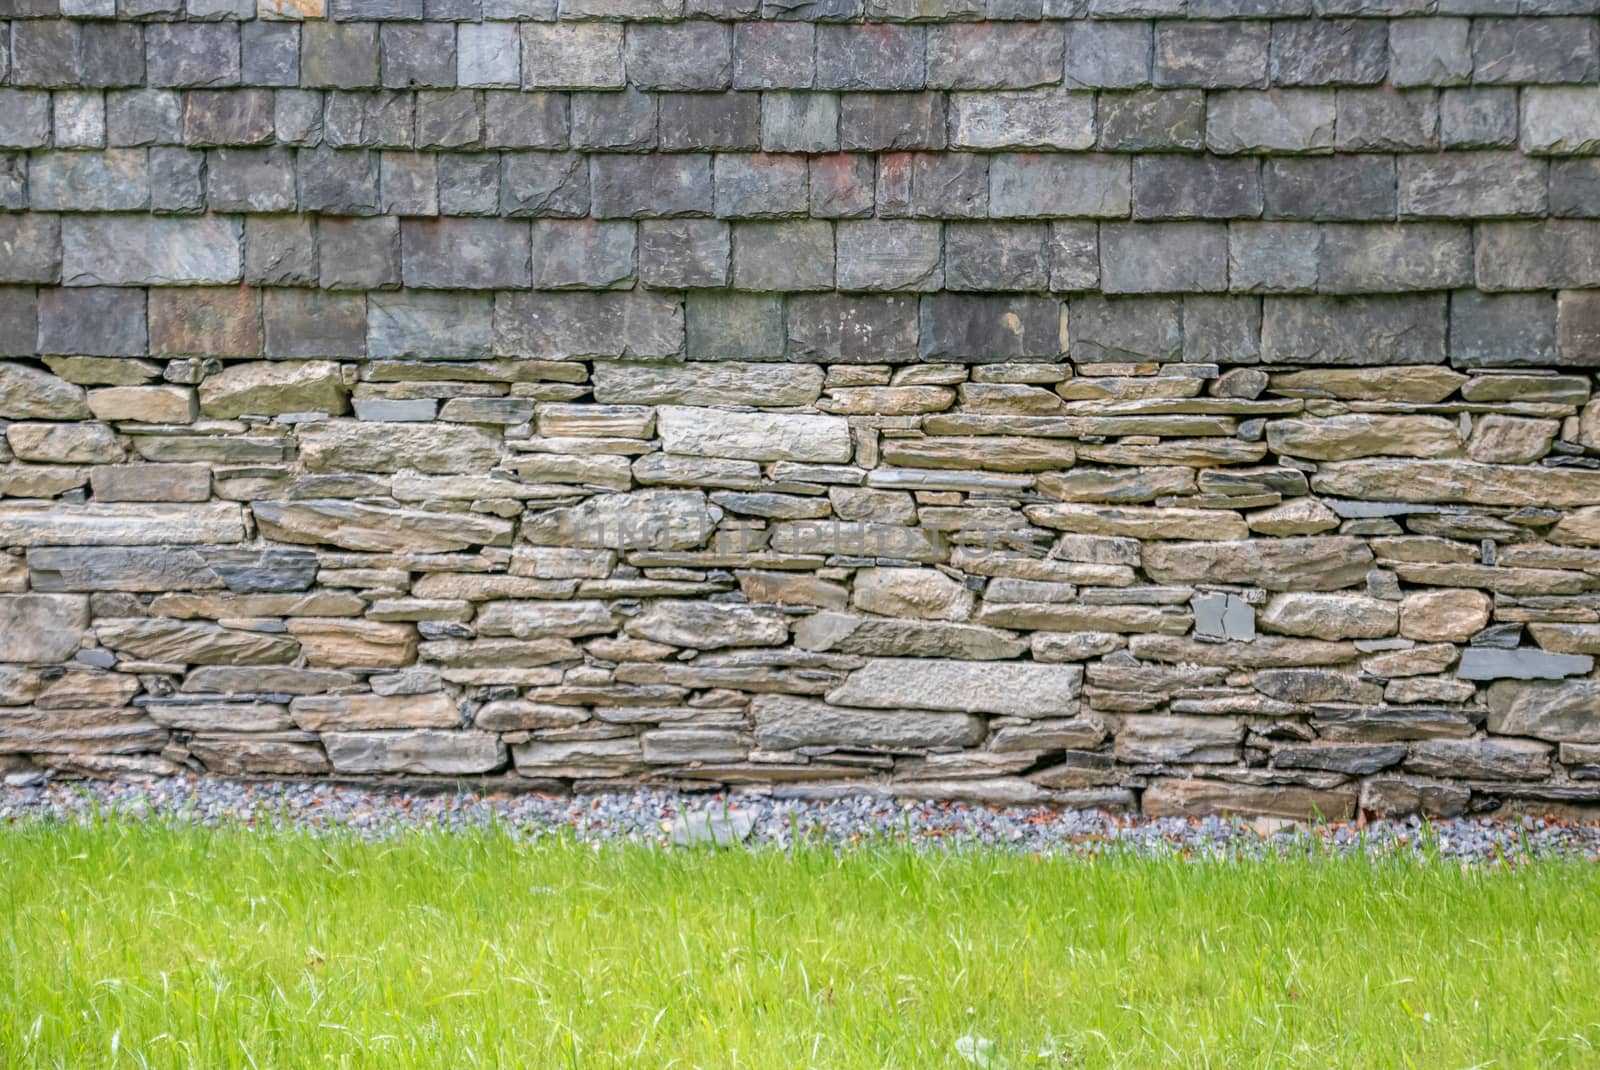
[{"xmin": 0, "ymin": 822, "xmax": 1600, "ymax": 1070}]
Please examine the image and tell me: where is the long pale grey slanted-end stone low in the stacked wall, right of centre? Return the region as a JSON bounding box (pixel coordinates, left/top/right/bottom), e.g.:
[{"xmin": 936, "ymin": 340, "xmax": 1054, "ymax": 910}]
[{"xmin": 827, "ymin": 657, "xmax": 1083, "ymax": 717}]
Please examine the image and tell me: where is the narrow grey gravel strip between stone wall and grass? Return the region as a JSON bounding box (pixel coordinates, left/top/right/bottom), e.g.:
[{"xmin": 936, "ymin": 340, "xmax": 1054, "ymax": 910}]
[{"xmin": 0, "ymin": 777, "xmax": 1600, "ymax": 862}]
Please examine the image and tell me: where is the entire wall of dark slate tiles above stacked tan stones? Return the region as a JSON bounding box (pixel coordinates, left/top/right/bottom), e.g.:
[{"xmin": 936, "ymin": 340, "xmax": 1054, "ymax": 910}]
[{"xmin": 0, "ymin": 0, "xmax": 1600, "ymax": 817}]
